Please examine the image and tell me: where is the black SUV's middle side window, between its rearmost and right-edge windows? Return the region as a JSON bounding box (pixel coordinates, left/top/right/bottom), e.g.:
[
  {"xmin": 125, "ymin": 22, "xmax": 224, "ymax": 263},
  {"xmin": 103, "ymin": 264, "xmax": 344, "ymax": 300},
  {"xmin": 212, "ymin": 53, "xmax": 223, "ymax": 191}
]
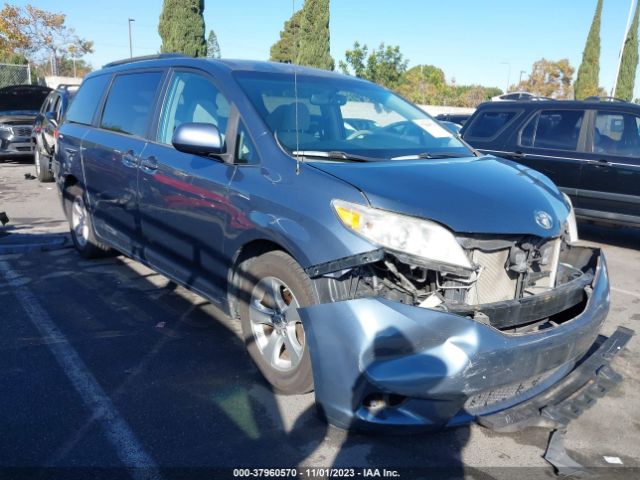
[{"xmin": 520, "ymin": 110, "xmax": 584, "ymax": 150}]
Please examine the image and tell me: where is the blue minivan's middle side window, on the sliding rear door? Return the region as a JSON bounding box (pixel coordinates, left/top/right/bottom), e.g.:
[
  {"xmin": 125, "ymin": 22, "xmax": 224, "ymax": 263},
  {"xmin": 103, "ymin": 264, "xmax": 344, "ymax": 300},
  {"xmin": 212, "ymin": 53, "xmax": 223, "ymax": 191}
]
[{"xmin": 100, "ymin": 72, "xmax": 162, "ymax": 137}]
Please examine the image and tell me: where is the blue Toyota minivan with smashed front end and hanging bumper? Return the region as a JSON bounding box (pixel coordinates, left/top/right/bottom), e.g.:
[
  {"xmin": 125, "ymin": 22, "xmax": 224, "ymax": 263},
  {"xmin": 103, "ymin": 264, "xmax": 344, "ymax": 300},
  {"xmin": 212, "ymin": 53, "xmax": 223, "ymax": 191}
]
[{"xmin": 54, "ymin": 54, "xmax": 632, "ymax": 430}]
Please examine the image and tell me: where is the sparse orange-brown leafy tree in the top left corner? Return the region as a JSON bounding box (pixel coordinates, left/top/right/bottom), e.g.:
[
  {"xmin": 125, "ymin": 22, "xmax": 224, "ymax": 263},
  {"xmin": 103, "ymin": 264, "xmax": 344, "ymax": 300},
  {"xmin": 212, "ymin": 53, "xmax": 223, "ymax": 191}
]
[{"xmin": 0, "ymin": 4, "xmax": 93, "ymax": 75}]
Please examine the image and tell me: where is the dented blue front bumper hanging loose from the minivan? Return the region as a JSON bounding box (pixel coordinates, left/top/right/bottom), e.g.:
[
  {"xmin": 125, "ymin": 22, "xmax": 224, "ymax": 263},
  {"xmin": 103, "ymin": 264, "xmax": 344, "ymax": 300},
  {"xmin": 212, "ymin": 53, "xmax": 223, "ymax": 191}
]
[{"xmin": 299, "ymin": 247, "xmax": 632, "ymax": 431}]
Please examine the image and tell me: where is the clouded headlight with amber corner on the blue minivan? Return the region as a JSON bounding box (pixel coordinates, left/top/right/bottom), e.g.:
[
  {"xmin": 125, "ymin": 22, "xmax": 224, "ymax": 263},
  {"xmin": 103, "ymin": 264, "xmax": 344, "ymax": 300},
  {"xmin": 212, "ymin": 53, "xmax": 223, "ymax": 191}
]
[{"xmin": 332, "ymin": 200, "xmax": 473, "ymax": 271}]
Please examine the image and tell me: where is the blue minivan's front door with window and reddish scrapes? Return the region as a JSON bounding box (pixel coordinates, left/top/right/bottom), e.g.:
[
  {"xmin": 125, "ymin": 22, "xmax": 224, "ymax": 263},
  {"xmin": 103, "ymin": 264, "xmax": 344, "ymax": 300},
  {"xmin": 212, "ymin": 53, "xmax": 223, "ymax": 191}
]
[{"xmin": 139, "ymin": 70, "xmax": 235, "ymax": 301}]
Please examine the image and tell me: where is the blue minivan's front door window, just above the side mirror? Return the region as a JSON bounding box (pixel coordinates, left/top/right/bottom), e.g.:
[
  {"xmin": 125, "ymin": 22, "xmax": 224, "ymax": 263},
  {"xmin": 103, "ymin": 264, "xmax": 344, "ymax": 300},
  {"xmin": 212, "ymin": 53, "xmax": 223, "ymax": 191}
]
[{"xmin": 157, "ymin": 72, "xmax": 230, "ymax": 145}]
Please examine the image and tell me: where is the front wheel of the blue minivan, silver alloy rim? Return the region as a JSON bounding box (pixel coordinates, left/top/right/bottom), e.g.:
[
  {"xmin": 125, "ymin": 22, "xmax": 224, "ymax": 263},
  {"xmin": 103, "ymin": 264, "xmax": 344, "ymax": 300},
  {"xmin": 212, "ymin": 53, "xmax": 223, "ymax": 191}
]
[{"xmin": 238, "ymin": 251, "xmax": 318, "ymax": 394}]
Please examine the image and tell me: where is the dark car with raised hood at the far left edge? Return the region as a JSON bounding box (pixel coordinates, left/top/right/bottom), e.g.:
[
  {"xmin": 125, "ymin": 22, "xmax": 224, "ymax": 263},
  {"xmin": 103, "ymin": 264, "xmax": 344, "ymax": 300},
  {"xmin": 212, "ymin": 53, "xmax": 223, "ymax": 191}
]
[{"xmin": 0, "ymin": 85, "xmax": 51, "ymax": 158}]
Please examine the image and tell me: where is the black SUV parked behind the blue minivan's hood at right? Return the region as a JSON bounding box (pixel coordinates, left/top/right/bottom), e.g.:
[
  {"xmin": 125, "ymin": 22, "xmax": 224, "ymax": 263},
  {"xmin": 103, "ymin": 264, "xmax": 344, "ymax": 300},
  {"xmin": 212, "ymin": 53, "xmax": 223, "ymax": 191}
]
[{"xmin": 462, "ymin": 99, "xmax": 640, "ymax": 226}]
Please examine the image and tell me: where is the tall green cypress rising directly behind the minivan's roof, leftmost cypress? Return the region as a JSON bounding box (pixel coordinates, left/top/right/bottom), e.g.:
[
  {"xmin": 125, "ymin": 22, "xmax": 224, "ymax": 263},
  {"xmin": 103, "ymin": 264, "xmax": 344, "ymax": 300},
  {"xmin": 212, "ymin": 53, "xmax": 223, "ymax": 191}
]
[{"xmin": 158, "ymin": 0, "xmax": 207, "ymax": 57}]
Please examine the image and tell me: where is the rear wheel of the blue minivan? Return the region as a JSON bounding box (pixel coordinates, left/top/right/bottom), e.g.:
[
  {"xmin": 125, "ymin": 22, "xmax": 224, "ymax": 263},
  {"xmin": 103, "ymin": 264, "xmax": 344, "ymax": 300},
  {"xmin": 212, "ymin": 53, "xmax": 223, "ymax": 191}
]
[{"xmin": 65, "ymin": 185, "xmax": 109, "ymax": 258}]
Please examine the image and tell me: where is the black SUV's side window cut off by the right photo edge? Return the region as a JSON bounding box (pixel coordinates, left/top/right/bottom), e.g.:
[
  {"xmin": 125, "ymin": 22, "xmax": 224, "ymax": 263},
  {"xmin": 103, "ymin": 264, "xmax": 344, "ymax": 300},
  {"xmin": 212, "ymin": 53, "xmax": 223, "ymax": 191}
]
[{"xmin": 593, "ymin": 112, "xmax": 640, "ymax": 157}]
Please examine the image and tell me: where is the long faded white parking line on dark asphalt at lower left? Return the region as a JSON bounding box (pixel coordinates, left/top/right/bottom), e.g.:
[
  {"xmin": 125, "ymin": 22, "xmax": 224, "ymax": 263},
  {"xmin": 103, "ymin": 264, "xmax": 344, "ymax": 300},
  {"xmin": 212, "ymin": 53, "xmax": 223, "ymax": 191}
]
[{"xmin": 0, "ymin": 261, "xmax": 161, "ymax": 480}]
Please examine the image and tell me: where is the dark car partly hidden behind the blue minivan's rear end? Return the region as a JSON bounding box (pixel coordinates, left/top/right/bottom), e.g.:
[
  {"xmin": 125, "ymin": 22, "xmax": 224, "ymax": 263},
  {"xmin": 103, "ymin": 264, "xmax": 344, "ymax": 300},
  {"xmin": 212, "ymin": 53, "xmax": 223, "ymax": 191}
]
[{"xmin": 33, "ymin": 85, "xmax": 78, "ymax": 182}]
